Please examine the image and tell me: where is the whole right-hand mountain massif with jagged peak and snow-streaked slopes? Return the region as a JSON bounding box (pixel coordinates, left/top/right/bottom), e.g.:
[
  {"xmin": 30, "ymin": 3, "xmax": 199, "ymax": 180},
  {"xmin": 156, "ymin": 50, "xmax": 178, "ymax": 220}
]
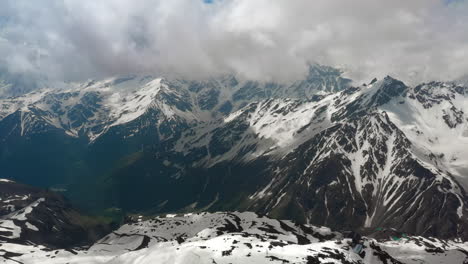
[{"xmin": 121, "ymin": 77, "xmax": 468, "ymax": 237}]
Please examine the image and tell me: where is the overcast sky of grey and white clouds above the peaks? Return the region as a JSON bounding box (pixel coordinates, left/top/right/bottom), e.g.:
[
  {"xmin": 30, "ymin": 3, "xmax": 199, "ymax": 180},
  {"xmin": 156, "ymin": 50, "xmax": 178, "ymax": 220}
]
[{"xmin": 0, "ymin": 0, "xmax": 468, "ymax": 82}]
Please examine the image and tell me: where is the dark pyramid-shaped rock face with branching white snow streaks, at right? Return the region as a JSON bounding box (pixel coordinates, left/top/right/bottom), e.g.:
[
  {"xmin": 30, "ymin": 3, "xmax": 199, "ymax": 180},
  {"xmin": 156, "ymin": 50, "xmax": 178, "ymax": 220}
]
[{"xmin": 243, "ymin": 110, "xmax": 466, "ymax": 237}]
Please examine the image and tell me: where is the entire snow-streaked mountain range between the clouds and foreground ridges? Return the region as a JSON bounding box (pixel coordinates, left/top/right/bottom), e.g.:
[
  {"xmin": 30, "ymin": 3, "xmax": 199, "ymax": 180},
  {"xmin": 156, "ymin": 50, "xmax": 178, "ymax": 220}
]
[{"xmin": 0, "ymin": 65, "xmax": 468, "ymax": 263}]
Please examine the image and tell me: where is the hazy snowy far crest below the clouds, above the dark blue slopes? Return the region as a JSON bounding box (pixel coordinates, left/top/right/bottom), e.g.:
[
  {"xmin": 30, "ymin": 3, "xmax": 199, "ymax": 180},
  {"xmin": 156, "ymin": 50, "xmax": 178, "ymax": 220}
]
[{"xmin": 0, "ymin": 66, "xmax": 350, "ymax": 141}]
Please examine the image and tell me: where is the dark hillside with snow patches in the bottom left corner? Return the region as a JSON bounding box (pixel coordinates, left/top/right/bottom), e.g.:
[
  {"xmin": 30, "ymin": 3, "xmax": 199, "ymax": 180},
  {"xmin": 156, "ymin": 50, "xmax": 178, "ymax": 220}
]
[{"xmin": 0, "ymin": 179, "xmax": 111, "ymax": 263}]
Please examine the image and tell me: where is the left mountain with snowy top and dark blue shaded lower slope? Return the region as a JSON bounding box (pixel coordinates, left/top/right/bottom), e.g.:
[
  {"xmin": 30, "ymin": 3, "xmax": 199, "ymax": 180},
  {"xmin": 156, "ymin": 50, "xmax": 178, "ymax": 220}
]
[{"xmin": 0, "ymin": 77, "xmax": 203, "ymax": 189}]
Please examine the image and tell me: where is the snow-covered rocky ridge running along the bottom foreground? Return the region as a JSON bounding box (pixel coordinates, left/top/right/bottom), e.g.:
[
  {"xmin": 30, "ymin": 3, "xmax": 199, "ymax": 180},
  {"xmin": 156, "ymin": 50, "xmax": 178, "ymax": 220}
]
[{"xmin": 0, "ymin": 212, "xmax": 468, "ymax": 264}]
